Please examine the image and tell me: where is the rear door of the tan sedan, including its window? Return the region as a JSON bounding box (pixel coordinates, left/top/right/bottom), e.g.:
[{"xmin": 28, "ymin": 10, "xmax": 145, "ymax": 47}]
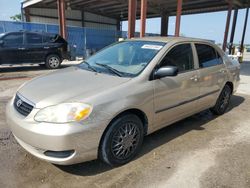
[{"xmin": 195, "ymin": 43, "xmax": 226, "ymax": 109}]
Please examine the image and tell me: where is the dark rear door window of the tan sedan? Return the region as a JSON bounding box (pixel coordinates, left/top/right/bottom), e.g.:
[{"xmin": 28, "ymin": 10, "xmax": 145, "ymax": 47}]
[{"xmin": 195, "ymin": 44, "xmax": 223, "ymax": 68}]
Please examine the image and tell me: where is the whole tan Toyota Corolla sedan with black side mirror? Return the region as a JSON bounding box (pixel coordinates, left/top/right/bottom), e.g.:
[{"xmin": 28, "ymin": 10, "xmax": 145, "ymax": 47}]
[{"xmin": 6, "ymin": 37, "xmax": 240, "ymax": 166}]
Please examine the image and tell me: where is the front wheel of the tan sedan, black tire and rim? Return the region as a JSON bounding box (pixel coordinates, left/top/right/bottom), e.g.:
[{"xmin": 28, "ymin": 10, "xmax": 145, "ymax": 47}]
[{"xmin": 99, "ymin": 114, "xmax": 144, "ymax": 166}]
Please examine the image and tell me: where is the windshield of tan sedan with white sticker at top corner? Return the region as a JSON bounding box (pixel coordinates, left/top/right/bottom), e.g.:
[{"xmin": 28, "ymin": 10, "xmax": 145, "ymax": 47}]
[{"xmin": 79, "ymin": 41, "xmax": 166, "ymax": 77}]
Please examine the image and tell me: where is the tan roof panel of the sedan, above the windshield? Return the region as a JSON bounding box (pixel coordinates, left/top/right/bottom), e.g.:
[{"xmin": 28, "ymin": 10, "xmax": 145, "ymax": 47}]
[{"xmin": 130, "ymin": 36, "xmax": 214, "ymax": 44}]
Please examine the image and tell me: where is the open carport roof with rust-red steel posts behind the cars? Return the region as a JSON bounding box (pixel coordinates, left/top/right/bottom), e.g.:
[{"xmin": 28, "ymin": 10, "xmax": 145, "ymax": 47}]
[{"xmin": 23, "ymin": 0, "xmax": 250, "ymax": 50}]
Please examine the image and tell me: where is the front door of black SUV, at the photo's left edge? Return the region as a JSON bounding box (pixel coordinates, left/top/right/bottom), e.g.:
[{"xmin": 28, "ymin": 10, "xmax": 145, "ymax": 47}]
[{"xmin": 0, "ymin": 32, "xmax": 25, "ymax": 64}]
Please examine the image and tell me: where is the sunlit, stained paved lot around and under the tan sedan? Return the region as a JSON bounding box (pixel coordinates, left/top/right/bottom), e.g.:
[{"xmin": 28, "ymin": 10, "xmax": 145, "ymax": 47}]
[{"xmin": 0, "ymin": 62, "xmax": 250, "ymax": 188}]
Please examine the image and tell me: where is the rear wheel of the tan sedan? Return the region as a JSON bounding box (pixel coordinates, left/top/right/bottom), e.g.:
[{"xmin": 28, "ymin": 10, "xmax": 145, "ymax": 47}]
[{"xmin": 211, "ymin": 85, "xmax": 232, "ymax": 115}]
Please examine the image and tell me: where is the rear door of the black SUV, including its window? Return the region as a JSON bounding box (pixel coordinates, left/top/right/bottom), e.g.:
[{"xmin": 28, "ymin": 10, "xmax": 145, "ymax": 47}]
[{"xmin": 25, "ymin": 33, "xmax": 46, "ymax": 62}]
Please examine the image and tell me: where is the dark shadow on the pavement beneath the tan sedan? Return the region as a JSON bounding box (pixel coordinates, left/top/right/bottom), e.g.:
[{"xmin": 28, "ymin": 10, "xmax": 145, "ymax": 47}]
[{"xmin": 55, "ymin": 96, "xmax": 245, "ymax": 176}]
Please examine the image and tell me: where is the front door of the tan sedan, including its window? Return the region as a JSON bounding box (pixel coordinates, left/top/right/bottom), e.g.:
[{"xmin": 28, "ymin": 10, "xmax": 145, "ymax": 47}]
[{"xmin": 154, "ymin": 43, "xmax": 199, "ymax": 130}]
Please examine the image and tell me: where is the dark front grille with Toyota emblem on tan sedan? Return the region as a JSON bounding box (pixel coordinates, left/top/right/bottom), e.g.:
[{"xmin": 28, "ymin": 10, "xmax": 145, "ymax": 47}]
[{"xmin": 14, "ymin": 95, "xmax": 34, "ymax": 117}]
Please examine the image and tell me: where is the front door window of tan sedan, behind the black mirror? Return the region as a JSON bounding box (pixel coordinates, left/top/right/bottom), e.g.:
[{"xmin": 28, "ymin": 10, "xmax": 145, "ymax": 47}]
[{"xmin": 161, "ymin": 44, "xmax": 194, "ymax": 72}]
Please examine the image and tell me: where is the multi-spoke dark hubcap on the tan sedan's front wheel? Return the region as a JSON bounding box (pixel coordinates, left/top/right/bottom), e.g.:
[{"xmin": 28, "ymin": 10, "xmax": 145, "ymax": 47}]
[{"xmin": 111, "ymin": 123, "xmax": 140, "ymax": 159}]
